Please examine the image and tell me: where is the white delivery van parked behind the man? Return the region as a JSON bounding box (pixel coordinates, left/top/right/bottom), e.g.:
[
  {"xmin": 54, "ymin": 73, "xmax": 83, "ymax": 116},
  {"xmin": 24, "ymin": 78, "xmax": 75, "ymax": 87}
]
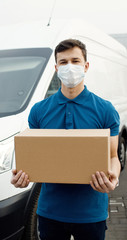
[{"xmin": 0, "ymin": 20, "xmax": 127, "ymax": 240}]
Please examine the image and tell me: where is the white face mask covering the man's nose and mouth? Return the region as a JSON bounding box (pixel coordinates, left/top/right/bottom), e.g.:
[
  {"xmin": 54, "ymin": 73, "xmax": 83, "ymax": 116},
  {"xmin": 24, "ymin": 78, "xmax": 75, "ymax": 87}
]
[{"xmin": 57, "ymin": 64, "xmax": 85, "ymax": 88}]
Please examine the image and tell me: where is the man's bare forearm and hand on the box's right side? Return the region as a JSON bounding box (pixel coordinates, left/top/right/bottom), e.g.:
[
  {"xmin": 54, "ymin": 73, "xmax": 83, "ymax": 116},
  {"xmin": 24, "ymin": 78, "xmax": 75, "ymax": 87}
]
[{"xmin": 90, "ymin": 136, "xmax": 120, "ymax": 193}]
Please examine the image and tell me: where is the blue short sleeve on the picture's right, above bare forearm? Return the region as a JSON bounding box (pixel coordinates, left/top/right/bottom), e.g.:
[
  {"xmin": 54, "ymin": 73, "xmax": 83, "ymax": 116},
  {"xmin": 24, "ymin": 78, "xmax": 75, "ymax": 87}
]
[{"xmin": 105, "ymin": 103, "xmax": 120, "ymax": 136}]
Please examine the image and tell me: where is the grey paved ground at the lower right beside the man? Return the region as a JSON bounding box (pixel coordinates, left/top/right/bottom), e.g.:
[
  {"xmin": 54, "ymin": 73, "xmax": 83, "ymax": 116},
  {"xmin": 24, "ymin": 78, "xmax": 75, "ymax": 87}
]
[{"xmin": 106, "ymin": 163, "xmax": 127, "ymax": 240}]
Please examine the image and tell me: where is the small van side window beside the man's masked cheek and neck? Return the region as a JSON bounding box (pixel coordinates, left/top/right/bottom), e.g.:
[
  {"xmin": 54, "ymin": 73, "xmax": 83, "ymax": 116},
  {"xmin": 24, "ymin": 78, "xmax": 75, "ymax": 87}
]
[{"xmin": 45, "ymin": 72, "xmax": 61, "ymax": 98}]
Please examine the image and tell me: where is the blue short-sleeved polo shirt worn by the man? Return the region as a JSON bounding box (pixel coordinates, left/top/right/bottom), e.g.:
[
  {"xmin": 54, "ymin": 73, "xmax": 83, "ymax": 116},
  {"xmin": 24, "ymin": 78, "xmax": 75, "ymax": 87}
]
[{"xmin": 28, "ymin": 86, "xmax": 119, "ymax": 223}]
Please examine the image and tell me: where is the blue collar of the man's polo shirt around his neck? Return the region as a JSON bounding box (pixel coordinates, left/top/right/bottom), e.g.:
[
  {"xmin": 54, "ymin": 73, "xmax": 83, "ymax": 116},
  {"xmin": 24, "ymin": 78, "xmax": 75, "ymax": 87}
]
[{"xmin": 57, "ymin": 86, "xmax": 90, "ymax": 104}]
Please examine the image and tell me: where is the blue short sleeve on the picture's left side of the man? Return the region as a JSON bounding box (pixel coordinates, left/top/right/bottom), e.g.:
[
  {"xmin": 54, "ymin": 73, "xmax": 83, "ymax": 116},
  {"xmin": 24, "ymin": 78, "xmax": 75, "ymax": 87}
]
[{"xmin": 28, "ymin": 104, "xmax": 39, "ymax": 129}]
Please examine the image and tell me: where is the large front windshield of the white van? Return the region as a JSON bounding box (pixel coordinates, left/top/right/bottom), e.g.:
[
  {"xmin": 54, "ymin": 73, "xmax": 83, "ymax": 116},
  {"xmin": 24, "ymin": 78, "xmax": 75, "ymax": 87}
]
[{"xmin": 0, "ymin": 48, "xmax": 52, "ymax": 117}]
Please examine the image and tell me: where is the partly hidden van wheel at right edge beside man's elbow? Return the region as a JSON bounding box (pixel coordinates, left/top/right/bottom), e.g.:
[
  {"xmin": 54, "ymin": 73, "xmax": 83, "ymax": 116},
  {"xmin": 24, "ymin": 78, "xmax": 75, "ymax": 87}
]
[{"xmin": 119, "ymin": 137, "xmax": 126, "ymax": 171}]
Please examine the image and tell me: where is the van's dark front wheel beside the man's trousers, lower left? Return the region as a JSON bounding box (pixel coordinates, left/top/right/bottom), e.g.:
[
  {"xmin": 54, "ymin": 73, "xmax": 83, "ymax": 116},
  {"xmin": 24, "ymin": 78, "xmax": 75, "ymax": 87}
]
[{"xmin": 21, "ymin": 184, "xmax": 41, "ymax": 240}]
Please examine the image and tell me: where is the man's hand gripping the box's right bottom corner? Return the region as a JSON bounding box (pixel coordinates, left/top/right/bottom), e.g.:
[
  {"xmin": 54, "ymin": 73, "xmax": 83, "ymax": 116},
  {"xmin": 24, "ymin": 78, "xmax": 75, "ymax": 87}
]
[{"xmin": 90, "ymin": 171, "xmax": 118, "ymax": 193}]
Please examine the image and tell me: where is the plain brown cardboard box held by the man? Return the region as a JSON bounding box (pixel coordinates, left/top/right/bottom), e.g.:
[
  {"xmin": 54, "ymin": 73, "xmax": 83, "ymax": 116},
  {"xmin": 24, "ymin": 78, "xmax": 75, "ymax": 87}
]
[{"xmin": 15, "ymin": 129, "xmax": 110, "ymax": 184}]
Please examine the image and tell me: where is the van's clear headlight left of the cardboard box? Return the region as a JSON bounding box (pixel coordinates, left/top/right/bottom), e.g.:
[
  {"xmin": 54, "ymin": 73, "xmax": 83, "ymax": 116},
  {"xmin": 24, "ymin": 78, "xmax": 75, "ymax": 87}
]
[{"xmin": 0, "ymin": 138, "xmax": 14, "ymax": 173}]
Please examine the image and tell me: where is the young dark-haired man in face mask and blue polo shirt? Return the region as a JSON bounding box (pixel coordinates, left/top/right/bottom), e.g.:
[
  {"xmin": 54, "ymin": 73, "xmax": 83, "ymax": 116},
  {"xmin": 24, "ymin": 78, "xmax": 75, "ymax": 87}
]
[{"xmin": 11, "ymin": 39, "xmax": 120, "ymax": 240}]
